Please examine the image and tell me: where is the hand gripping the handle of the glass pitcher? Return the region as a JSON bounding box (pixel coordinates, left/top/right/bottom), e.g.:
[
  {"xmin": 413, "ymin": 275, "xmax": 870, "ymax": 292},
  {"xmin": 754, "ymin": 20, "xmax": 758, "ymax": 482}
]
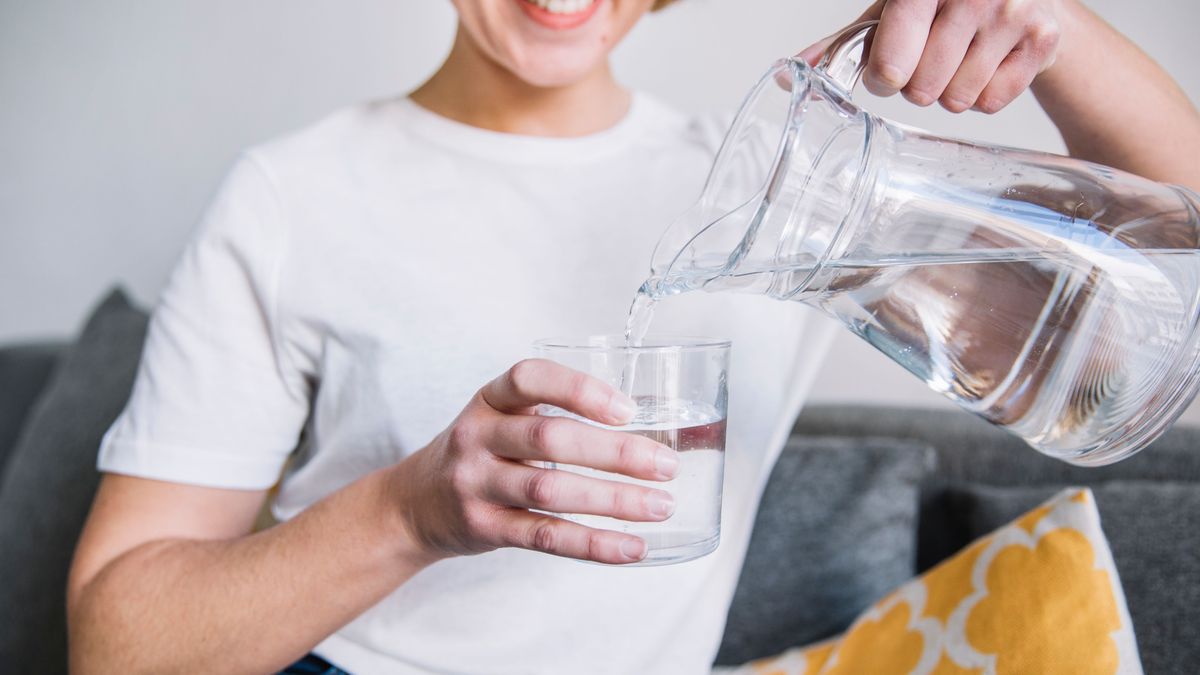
[{"xmin": 800, "ymin": 0, "xmax": 1074, "ymax": 113}]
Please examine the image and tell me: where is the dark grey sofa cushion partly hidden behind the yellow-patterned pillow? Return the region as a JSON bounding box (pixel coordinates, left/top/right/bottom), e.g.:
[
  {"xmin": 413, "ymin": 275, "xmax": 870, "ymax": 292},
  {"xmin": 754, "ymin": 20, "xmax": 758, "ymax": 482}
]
[{"xmin": 946, "ymin": 480, "xmax": 1200, "ymax": 673}]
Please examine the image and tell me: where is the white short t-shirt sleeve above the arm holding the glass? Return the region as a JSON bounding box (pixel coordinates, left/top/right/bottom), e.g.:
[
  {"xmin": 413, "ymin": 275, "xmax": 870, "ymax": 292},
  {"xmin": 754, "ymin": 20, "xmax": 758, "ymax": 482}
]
[{"xmin": 97, "ymin": 154, "xmax": 310, "ymax": 489}]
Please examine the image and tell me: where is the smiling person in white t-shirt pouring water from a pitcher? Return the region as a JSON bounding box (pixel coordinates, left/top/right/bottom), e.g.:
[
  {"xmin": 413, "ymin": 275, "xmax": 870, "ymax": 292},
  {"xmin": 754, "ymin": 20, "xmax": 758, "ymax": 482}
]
[{"xmin": 68, "ymin": 0, "xmax": 1200, "ymax": 674}]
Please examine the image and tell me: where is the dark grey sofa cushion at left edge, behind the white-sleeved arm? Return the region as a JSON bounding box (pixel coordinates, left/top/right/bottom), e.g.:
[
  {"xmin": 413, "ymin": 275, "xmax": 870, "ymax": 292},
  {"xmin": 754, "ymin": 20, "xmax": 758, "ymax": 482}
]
[{"xmin": 0, "ymin": 291, "xmax": 146, "ymax": 674}]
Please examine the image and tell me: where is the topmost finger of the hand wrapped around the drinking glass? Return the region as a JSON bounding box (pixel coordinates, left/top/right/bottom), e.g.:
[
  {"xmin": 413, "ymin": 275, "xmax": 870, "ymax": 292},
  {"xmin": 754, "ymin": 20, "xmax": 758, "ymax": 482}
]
[{"xmin": 480, "ymin": 359, "xmax": 637, "ymax": 424}]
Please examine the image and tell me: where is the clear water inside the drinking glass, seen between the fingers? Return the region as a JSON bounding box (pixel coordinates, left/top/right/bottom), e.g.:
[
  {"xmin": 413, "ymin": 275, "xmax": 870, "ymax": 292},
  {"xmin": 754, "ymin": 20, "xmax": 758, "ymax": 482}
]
[{"xmin": 553, "ymin": 398, "xmax": 725, "ymax": 566}]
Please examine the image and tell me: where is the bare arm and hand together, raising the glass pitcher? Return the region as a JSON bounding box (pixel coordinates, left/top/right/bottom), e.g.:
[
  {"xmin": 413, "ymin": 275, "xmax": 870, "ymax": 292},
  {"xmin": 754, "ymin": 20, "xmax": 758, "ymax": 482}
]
[{"xmin": 800, "ymin": 0, "xmax": 1200, "ymax": 190}]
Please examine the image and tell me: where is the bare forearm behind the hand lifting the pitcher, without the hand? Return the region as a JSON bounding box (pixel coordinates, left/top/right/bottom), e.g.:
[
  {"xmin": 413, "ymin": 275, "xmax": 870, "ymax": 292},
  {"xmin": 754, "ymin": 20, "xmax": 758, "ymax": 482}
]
[{"xmin": 1033, "ymin": 0, "xmax": 1200, "ymax": 190}]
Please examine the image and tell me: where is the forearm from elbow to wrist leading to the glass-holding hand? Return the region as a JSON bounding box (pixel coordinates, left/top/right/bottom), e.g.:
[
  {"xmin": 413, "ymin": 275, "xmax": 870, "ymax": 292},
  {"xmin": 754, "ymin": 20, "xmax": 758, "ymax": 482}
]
[{"xmin": 70, "ymin": 472, "xmax": 431, "ymax": 674}]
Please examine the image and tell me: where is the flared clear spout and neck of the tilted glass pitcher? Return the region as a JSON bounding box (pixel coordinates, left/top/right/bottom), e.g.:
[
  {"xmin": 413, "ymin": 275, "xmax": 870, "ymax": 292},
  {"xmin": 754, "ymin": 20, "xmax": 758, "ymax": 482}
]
[{"xmin": 652, "ymin": 64, "xmax": 871, "ymax": 299}]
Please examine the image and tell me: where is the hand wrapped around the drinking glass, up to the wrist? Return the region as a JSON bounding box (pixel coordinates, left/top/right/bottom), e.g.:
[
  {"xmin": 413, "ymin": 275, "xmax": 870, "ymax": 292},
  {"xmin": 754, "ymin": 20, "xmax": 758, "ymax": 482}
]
[{"xmin": 390, "ymin": 360, "xmax": 679, "ymax": 563}]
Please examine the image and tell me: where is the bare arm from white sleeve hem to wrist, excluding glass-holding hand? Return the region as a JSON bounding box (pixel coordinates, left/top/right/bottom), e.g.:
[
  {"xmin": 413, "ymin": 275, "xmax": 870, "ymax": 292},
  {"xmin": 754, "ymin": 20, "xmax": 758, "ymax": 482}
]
[{"xmin": 67, "ymin": 473, "xmax": 428, "ymax": 674}]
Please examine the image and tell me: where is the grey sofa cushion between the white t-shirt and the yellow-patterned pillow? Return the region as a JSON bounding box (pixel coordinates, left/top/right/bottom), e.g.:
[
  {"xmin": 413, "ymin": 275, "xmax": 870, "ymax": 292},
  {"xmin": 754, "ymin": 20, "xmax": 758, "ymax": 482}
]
[{"xmin": 716, "ymin": 438, "xmax": 934, "ymax": 664}]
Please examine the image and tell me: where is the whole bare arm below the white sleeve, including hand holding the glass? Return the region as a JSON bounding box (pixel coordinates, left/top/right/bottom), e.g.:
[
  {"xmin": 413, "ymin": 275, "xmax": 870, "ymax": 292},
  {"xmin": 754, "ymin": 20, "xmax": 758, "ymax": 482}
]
[{"xmin": 67, "ymin": 360, "xmax": 678, "ymax": 674}]
